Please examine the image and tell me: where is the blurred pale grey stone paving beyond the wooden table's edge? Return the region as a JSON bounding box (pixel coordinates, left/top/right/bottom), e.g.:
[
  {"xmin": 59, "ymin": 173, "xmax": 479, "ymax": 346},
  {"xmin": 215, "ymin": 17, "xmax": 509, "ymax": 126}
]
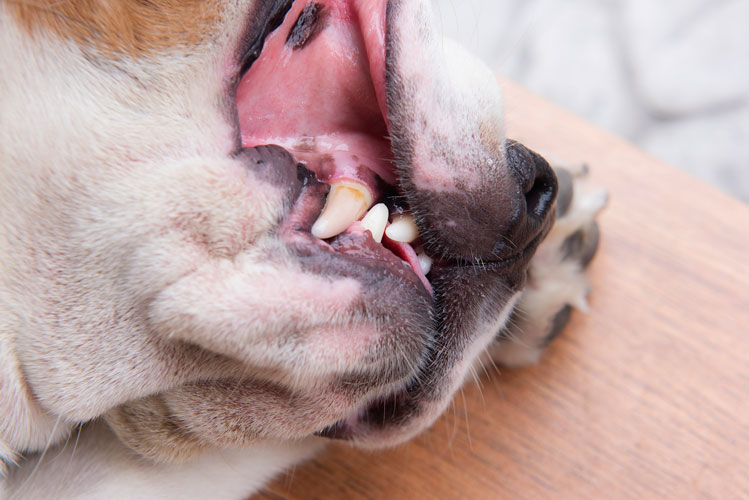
[{"xmin": 434, "ymin": 0, "xmax": 749, "ymax": 203}]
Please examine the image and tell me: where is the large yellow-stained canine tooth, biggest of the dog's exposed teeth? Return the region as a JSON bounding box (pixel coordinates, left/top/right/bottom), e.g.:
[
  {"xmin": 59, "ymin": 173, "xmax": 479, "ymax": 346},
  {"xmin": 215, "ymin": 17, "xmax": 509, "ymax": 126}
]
[{"xmin": 312, "ymin": 181, "xmax": 372, "ymax": 240}]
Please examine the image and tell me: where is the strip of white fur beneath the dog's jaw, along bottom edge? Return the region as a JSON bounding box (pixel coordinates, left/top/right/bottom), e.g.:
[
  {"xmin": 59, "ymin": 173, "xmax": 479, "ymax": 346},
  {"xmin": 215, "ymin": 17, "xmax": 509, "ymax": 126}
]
[{"xmin": 3, "ymin": 424, "xmax": 324, "ymax": 500}]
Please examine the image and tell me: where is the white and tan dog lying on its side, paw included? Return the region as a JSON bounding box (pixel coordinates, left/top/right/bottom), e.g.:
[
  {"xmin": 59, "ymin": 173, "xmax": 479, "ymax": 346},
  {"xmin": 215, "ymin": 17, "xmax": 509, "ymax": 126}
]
[{"xmin": 0, "ymin": 0, "xmax": 605, "ymax": 499}]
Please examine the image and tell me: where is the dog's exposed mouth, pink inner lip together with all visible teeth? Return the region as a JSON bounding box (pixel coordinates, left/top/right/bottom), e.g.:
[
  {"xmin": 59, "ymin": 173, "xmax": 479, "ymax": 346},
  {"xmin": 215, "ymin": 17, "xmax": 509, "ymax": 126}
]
[{"xmin": 237, "ymin": 0, "xmax": 433, "ymax": 294}]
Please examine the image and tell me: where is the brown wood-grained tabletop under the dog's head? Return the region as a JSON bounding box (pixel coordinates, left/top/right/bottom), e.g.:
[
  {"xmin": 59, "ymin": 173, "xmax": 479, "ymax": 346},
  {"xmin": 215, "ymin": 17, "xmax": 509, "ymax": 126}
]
[{"xmin": 260, "ymin": 83, "xmax": 749, "ymax": 499}]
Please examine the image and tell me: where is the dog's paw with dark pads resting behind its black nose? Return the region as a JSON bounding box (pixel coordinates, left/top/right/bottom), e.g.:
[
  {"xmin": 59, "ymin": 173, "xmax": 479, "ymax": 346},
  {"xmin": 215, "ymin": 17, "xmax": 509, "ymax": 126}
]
[{"xmin": 488, "ymin": 165, "xmax": 608, "ymax": 367}]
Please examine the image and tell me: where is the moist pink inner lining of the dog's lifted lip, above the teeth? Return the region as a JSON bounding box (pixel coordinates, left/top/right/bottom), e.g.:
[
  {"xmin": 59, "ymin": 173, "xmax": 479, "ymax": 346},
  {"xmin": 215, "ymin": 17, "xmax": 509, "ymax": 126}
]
[{"xmin": 237, "ymin": 0, "xmax": 395, "ymax": 189}]
